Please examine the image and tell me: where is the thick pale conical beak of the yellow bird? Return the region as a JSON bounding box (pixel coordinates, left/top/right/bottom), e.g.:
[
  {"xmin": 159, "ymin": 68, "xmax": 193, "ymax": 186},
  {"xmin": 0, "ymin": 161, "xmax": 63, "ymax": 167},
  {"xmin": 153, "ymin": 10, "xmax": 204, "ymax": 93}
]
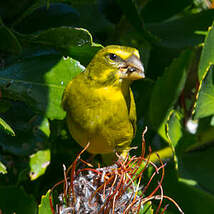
[{"xmin": 120, "ymin": 55, "xmax": 145, "ymax": 80}]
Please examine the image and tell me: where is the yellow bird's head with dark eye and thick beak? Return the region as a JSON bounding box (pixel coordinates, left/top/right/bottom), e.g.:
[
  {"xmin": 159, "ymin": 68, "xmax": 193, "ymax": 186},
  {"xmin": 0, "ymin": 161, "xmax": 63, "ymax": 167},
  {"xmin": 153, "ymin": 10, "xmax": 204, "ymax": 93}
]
[{"xmin": 87, "ymin": 45, "xmax": 145, "ymax": 84}]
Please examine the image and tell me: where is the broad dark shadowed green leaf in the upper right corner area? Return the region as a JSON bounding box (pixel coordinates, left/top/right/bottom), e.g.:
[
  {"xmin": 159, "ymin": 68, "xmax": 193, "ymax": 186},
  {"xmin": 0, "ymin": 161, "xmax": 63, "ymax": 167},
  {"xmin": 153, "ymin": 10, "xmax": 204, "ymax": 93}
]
[{"xmin": 146, "ymin": 10, "xmax": 214, "ymax": 49}]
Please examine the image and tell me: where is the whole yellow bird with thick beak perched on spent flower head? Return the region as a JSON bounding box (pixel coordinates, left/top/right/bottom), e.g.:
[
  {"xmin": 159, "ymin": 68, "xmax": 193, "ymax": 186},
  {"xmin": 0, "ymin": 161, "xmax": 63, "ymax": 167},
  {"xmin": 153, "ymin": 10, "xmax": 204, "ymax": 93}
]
[{"xmin": 62, "ymin": 45, "xmax": 145, "ymax": 156}]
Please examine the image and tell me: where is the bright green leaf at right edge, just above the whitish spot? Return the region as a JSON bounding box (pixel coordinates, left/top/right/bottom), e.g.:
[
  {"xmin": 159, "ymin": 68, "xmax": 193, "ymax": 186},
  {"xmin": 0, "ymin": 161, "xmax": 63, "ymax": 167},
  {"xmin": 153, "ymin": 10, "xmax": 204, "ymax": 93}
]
[{"xmin": 194, "ymin": 65, "xmax": 214, "ymax": 119}]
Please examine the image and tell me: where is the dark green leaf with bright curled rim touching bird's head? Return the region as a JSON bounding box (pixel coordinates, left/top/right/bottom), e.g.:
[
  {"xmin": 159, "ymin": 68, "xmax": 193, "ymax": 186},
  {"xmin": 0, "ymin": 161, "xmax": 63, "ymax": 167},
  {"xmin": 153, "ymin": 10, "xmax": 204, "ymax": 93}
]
[{"xmin": 24, "ymin": 26, "xmax": 102, "ymax": 65}]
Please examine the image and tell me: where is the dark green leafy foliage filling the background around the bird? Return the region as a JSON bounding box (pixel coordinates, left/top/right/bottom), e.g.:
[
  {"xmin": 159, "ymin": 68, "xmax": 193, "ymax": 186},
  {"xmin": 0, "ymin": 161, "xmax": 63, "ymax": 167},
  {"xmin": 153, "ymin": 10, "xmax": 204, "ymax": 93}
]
[{"xmin": 0, "ymin": 0, "xmax": 214, "ymax": 214}]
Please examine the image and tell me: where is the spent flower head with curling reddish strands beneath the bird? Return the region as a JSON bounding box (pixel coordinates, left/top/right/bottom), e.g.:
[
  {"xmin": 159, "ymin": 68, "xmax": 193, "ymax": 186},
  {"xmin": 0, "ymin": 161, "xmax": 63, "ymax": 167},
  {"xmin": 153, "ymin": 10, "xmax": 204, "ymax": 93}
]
[{"xmin": 50, "ymin": 129, "xmax": 183, "ymax": 214}]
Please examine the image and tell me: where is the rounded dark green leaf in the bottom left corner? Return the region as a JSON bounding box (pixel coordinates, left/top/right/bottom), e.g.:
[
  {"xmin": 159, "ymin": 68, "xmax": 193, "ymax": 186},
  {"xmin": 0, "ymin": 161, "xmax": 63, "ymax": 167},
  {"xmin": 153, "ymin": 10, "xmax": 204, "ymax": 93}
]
[{"xmin": 0, "ymin": 186, "xmax": 37, "ymax": 214}]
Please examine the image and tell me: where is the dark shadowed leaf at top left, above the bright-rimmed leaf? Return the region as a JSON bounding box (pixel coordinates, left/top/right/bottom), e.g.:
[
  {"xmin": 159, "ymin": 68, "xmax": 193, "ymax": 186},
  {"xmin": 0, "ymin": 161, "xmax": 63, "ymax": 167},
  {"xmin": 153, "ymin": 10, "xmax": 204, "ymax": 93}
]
[{"xmin": 15, "ymin": 1, "xmax": 114, "ymax": 45}]
